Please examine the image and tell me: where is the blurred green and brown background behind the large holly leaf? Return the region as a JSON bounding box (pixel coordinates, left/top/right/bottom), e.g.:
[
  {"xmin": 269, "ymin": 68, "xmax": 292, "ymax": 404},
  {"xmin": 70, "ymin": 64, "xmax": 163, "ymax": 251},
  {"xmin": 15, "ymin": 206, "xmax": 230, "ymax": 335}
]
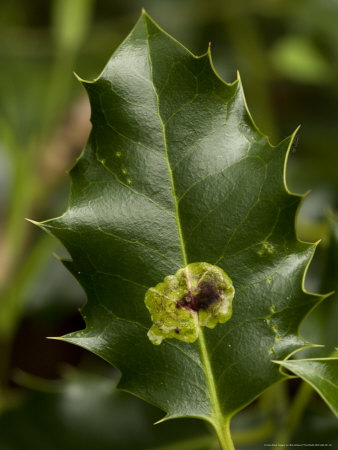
[{"xmin": 0, "ymin": 0, "xmax": 338, "ymax": 450}]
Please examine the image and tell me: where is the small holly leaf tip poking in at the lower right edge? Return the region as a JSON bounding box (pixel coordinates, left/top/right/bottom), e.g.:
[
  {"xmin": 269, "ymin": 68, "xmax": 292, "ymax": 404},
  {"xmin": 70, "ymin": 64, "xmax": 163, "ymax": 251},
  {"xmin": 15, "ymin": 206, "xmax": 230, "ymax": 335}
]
[{"xmin": 278, "ymin": 358, "xmax": 338, "ymax": 417}]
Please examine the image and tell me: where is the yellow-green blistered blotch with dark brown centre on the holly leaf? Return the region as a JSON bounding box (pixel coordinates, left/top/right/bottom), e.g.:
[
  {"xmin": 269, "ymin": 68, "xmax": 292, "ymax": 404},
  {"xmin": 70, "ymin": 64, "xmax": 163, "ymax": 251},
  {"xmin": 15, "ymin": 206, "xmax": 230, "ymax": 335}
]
[{"xmin": 145, "ymin": 263, "xmax": 235, "ymax": 345}]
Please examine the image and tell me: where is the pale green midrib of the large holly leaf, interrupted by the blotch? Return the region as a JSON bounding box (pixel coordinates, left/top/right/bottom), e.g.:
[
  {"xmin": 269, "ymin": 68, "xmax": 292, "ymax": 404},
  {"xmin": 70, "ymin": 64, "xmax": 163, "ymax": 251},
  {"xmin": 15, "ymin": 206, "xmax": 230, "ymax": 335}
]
[{"xmin": 145, "ymin": 17, "xmax": 225, "ymax": 432}]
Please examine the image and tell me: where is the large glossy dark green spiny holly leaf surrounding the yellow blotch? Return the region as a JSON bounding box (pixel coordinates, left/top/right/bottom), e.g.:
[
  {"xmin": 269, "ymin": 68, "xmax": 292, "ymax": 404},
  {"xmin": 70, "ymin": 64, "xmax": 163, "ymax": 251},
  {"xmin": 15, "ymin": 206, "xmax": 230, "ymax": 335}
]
[{"xmin": 36, "ymin": 13, "xmax": 320, "ymax": 448}]
